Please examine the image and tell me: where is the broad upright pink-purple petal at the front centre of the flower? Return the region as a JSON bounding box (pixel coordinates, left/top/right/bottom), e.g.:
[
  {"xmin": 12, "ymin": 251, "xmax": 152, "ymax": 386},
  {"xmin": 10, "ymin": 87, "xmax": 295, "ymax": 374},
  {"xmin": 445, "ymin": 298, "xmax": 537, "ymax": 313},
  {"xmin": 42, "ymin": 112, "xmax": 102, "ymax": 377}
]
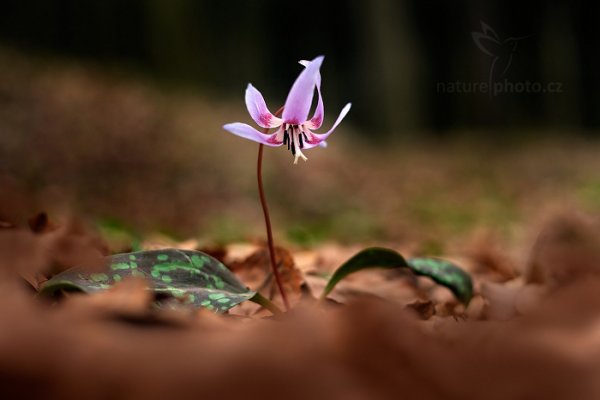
[{"xmin": 283, "ymin": 56, "xmax": 324, "ymax": 125}]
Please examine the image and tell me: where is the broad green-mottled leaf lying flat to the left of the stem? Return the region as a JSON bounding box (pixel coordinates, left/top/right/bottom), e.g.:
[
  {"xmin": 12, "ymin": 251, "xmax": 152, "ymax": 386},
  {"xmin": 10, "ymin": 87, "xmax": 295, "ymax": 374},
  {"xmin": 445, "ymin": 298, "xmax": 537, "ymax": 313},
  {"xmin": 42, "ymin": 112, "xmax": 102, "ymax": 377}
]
[{"xmin": 40, "ymin": 249, "xmax": 264, "ymax": 313}]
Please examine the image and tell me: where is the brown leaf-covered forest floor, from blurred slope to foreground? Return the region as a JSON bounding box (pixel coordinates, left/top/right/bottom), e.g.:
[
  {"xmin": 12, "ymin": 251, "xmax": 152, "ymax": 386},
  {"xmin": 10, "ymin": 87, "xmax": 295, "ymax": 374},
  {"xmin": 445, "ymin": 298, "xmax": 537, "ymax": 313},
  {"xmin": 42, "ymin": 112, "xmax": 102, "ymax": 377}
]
[{"xmin": 0, "ymin": 51, "xmax": 600, "ymax": 399}]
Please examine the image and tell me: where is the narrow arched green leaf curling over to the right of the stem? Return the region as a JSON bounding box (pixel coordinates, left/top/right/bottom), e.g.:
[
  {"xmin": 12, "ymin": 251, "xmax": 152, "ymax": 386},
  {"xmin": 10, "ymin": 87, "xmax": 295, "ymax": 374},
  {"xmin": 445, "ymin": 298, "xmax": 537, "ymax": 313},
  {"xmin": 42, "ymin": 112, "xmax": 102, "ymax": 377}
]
[{"xmin": 321, "ymin": 247, "xmax": 473, "ymax": 305}]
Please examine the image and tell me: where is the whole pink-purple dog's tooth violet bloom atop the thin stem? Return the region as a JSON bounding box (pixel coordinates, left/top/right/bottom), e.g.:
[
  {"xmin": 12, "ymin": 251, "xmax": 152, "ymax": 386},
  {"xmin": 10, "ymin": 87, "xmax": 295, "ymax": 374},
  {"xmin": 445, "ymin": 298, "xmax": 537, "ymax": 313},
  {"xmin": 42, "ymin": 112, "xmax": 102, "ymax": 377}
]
[{"xmin": 223, "ymin": 56, "xmax": 352, "ymax": 164}]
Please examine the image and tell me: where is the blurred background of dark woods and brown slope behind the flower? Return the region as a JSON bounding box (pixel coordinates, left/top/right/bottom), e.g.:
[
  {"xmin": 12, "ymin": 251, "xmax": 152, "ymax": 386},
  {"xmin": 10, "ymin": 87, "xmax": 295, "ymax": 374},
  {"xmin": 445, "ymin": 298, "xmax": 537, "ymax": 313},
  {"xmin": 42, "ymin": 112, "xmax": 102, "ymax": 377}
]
[{"xmin": 0, "ymin": 0, "xmax": 600, "ymax": 252}]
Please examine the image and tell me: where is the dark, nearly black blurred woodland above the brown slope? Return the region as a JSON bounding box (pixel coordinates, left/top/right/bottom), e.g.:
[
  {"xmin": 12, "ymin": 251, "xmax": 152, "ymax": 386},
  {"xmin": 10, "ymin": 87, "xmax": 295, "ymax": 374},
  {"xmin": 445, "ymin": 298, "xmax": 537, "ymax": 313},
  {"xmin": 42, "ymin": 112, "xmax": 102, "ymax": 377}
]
[{"xmin": 0, "ymin": 0, "xmax": 600, "ymax": 136}]
